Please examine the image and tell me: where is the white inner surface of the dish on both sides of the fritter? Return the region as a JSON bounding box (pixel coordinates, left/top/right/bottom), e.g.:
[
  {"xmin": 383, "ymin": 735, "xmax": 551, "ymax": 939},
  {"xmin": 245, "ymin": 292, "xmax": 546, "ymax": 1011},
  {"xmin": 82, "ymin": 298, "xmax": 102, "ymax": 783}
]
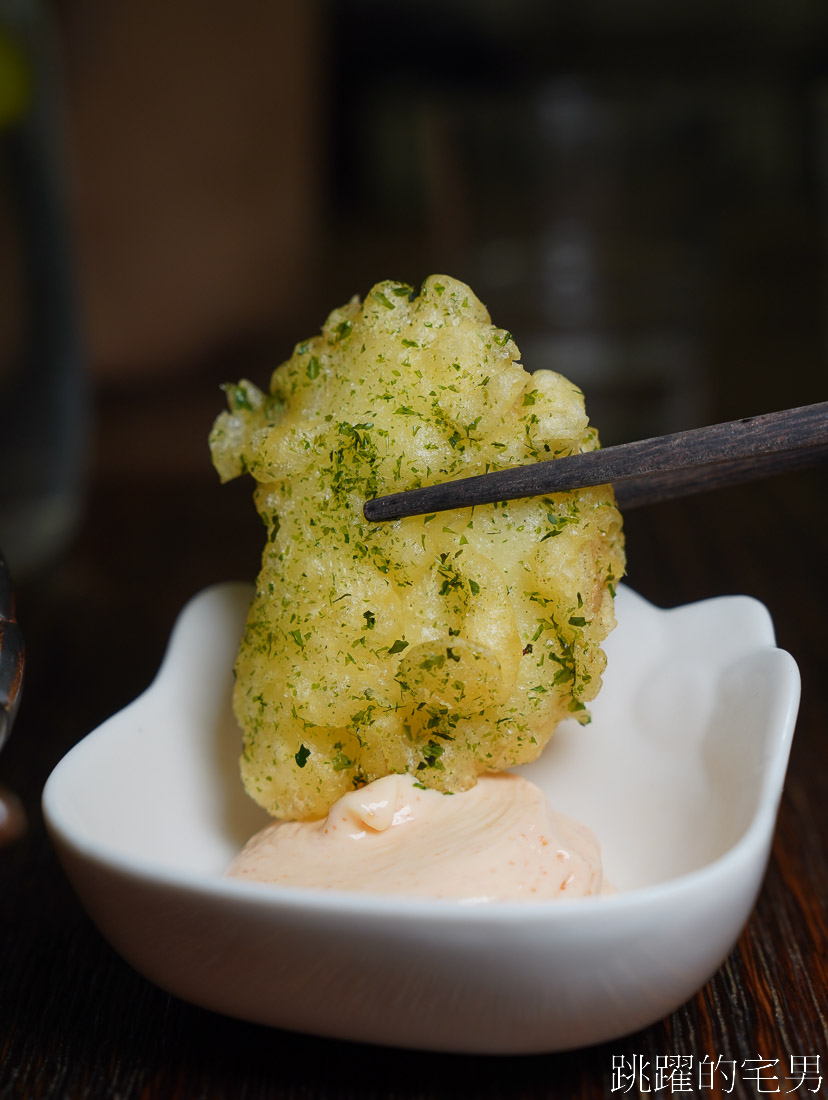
[{"xmin": 47, "ymin": 584, "xmax": 798, "ymax": 891}]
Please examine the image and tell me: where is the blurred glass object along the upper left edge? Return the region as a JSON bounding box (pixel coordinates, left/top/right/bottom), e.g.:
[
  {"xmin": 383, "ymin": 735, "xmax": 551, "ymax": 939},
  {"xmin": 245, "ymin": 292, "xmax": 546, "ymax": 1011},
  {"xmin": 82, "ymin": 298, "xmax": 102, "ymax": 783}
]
[{"xmin": 0, "ymin": 0, "xmax": 87, "ymax": 578}]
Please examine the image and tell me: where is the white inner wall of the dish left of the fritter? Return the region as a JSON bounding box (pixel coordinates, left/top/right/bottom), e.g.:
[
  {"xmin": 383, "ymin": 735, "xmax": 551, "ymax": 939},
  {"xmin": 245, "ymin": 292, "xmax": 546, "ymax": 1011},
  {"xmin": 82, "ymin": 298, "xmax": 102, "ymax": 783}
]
[{"xmin": 46, "ymin": 584, "xmax": 269, "ymax": 876}]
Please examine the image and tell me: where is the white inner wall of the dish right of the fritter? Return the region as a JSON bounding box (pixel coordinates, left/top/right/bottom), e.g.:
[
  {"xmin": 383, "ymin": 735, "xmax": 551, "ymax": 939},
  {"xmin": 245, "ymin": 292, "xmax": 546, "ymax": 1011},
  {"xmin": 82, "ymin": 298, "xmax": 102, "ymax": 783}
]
[{"xmin": 523, "ymin": 589, "xmax": 798, "ymax": 890}]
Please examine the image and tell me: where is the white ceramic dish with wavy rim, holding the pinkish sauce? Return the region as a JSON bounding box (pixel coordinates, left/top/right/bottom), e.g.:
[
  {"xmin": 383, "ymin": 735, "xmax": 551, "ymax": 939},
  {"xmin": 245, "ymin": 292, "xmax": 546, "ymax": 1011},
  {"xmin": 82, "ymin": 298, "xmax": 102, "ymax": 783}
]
[{"xmin": 44, "ymin": 584, "xmax": 799, "ymax": 1054}]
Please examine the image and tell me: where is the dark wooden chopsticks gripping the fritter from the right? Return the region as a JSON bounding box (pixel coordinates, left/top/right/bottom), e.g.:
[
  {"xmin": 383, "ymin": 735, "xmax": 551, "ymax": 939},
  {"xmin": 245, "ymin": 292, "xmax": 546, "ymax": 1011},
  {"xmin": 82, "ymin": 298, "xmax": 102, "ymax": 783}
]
[{"xmin": 364, "ymin": 402, "xmax": 828, "ymax": 521}]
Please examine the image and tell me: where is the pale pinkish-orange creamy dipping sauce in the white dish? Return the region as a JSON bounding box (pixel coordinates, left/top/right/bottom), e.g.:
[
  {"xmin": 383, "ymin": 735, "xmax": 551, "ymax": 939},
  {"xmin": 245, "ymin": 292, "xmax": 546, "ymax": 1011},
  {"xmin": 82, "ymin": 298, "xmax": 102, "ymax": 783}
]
[{"xmin": 227, "ymin": 772, "xmax": 611, "ymax": 903}]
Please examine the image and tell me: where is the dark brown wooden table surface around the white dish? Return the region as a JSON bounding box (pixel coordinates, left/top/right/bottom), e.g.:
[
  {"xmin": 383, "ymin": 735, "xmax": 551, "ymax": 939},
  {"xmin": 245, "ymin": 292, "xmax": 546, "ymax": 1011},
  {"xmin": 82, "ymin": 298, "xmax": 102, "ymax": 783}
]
[{"xmin": 0, "ymin": 380, "xmax": 828, "ymax": 1100}]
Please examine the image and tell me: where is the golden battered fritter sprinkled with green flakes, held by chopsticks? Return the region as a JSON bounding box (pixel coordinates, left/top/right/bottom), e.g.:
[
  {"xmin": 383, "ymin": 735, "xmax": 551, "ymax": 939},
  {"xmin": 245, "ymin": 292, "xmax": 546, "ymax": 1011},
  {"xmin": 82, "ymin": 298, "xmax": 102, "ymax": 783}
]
[{"xmin": 210, "ymin": 276, "xmax": 625, "ymax": 820}]
